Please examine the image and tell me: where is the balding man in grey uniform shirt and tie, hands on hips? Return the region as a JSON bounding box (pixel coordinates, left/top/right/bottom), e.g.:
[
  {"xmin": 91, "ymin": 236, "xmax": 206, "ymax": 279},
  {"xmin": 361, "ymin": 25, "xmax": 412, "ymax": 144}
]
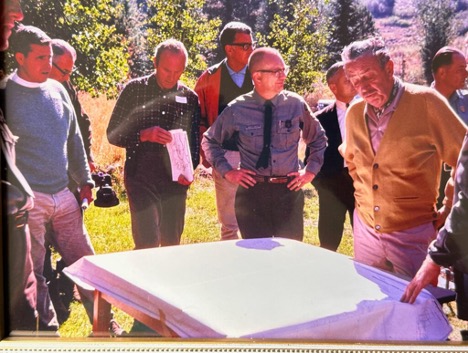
[{"xmin": 202, "ymin": 48, "xmax": 327, "ymax": 240}]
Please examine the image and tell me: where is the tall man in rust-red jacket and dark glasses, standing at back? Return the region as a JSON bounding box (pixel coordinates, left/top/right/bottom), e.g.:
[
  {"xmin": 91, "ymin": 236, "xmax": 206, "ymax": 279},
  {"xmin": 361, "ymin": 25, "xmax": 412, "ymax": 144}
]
[{"xmin": 195, "ymin": 22, "xmax": 255, "ymax": 240}]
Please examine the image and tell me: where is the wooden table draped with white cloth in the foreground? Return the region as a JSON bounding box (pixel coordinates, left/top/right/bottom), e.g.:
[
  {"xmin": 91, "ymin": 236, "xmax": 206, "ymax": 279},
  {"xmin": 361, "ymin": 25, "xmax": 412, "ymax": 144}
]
[{"xmin": 64, "ymin": 238, "xmax": 451, "ymax": 341}]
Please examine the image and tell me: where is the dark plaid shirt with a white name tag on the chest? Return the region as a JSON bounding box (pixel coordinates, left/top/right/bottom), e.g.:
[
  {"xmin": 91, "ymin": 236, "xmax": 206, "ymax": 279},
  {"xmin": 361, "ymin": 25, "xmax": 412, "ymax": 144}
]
[{"xmin": 107, "ymin": 74, "xmax": 200, "ymax": 168}]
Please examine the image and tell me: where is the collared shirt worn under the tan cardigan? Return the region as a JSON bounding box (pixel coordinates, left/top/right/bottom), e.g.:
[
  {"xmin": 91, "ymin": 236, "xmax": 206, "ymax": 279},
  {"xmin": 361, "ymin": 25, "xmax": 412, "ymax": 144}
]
[{"xmin": 364, "ymin": 77, "xmax": 405, "ymax": 153}]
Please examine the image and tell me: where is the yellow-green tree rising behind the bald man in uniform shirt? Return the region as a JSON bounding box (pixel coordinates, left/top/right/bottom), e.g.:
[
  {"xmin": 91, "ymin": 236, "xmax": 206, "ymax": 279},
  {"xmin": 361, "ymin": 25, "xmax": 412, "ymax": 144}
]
[{"xmin": 257, "ymin": 0, "xmax": 326, "ymax": 94}]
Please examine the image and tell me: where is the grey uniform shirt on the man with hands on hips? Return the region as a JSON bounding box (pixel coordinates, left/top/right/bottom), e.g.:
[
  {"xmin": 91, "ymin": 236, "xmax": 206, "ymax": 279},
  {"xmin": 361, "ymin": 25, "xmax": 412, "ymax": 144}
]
[{"xmin": 202, "ymin": 90, "xmax": 327, "ymax": 176}]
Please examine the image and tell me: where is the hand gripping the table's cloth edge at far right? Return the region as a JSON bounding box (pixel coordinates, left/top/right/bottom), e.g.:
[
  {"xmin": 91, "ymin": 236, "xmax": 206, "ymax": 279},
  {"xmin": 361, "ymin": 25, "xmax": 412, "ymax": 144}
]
[{"xmin": 400, "ymin": 256, "xmax": 440, "ymax": 304}]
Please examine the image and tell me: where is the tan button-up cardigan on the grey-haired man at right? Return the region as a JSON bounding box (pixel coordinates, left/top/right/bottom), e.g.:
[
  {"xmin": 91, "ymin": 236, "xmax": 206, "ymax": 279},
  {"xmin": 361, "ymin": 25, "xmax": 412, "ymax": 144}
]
[{"xmin": 345, "ymin": 84, "xmax": 466, "ymax": 233}]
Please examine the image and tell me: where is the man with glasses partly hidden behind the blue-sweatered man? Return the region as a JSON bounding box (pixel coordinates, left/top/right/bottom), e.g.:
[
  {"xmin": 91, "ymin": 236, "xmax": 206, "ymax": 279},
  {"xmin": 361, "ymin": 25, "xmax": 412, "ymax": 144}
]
[{"xmin": 49, "ymin": 39, "xmax": 96, "ymax": 172}]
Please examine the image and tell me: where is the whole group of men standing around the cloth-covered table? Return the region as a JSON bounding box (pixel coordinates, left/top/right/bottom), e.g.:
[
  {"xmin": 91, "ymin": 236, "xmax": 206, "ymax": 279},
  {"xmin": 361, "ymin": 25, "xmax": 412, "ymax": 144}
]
[{"xmin": 0, "ymin": 0, "xmax": 468, "ymax": 334}]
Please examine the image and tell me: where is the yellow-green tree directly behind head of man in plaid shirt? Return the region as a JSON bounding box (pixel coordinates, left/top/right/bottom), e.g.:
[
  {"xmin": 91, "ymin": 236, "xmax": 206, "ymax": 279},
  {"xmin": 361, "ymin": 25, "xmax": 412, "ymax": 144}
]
[{"xmin": 147, "ymin": 0, "xmax": 221, "ymax": 84}]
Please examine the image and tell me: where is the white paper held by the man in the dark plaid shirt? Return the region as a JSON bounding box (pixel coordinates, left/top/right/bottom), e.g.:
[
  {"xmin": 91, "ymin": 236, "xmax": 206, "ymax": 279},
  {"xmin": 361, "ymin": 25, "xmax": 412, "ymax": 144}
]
[{"xmin": 166, "ymin": 129, "xmax": 193, "ymax": 182}]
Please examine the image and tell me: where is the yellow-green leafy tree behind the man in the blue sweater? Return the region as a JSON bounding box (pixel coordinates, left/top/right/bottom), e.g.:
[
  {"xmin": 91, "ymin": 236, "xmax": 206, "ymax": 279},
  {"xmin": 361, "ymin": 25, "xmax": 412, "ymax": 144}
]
[{"xmin": 23, "ymin": 0, "xmax": 129, "ymax": 96}]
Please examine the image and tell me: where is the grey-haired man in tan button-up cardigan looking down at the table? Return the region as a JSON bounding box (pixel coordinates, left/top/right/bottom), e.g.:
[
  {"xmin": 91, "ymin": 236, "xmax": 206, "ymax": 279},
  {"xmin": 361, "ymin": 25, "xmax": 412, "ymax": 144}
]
[{"xmin": 342, "ymin": 38, "xmax": 466, "ymax": 277}]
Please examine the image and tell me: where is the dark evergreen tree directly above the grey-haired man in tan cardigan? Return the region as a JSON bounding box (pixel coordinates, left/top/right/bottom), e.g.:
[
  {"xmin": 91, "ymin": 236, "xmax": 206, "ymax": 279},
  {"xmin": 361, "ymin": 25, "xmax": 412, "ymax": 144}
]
[{"xmin": 326, "ymin": 0, "xmax": 376, "ymax": 68}]
